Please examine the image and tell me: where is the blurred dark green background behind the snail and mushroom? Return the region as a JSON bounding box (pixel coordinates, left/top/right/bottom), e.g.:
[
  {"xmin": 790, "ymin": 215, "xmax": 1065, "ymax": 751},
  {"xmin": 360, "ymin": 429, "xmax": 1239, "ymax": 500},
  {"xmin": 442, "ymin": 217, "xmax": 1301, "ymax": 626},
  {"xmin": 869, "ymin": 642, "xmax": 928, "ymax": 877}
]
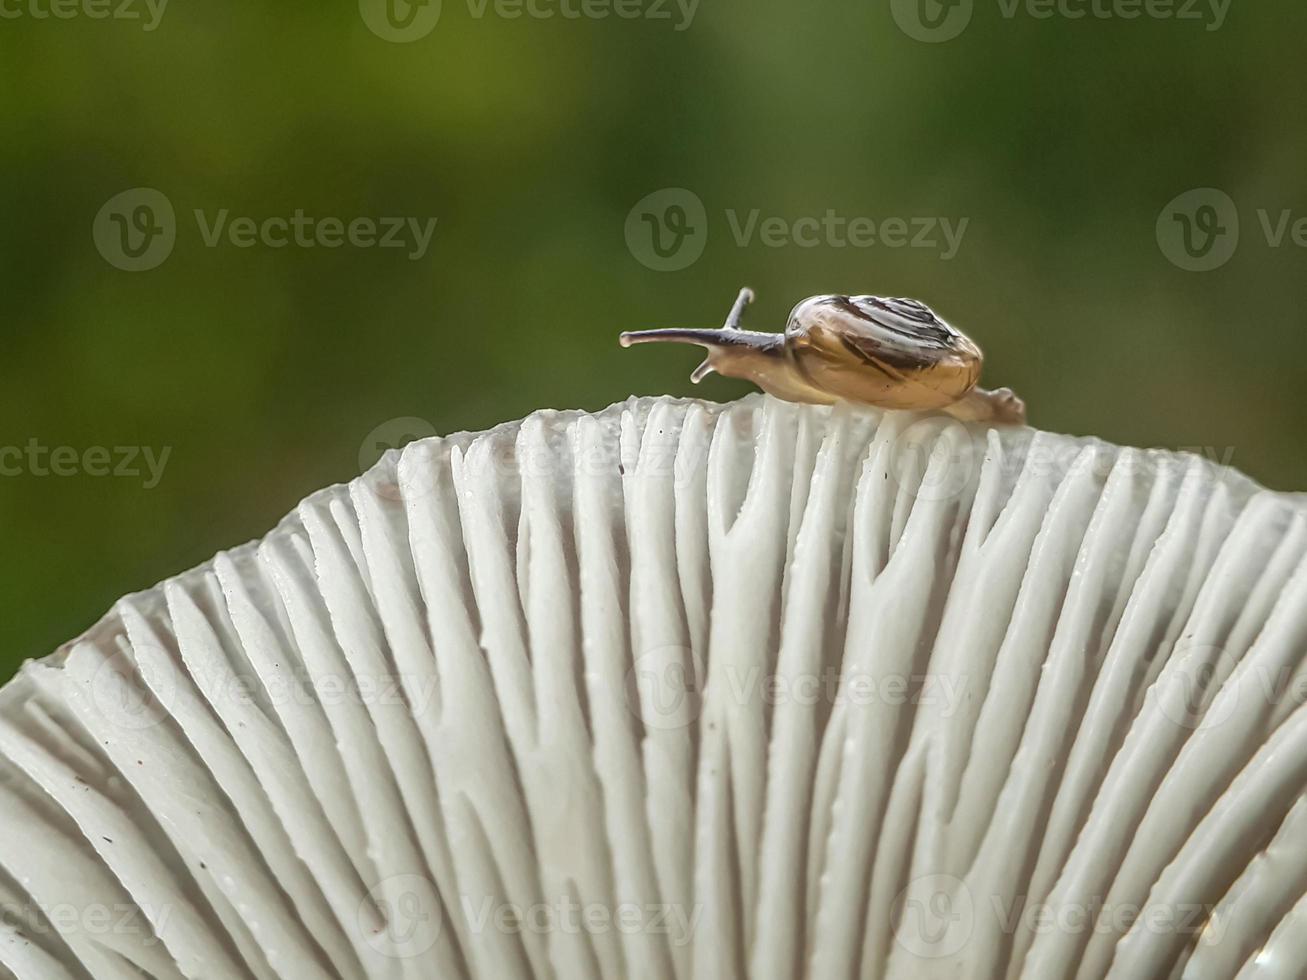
[{"xmin": 0, "ymin": 0, "xmax": 1307, "ymax": 676}]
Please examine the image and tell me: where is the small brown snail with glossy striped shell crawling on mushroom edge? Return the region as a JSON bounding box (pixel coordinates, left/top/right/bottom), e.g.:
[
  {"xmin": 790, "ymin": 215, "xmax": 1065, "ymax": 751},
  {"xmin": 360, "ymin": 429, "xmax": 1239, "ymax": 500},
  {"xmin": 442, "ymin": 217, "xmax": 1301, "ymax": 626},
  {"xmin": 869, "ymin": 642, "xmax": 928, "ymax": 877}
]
[{"xmin": 621, "ymin": 289, "xmax": 1026, "ymax": 425}]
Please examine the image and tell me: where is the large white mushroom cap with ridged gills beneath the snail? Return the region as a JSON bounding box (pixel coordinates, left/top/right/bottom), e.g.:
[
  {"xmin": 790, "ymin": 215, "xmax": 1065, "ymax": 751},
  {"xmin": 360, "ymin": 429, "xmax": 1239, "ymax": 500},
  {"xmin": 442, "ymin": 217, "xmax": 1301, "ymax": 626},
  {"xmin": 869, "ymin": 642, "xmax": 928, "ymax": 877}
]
[{"xmin": 0, "ymin": 396, "xmax": 1307, "ymax": 980}]
